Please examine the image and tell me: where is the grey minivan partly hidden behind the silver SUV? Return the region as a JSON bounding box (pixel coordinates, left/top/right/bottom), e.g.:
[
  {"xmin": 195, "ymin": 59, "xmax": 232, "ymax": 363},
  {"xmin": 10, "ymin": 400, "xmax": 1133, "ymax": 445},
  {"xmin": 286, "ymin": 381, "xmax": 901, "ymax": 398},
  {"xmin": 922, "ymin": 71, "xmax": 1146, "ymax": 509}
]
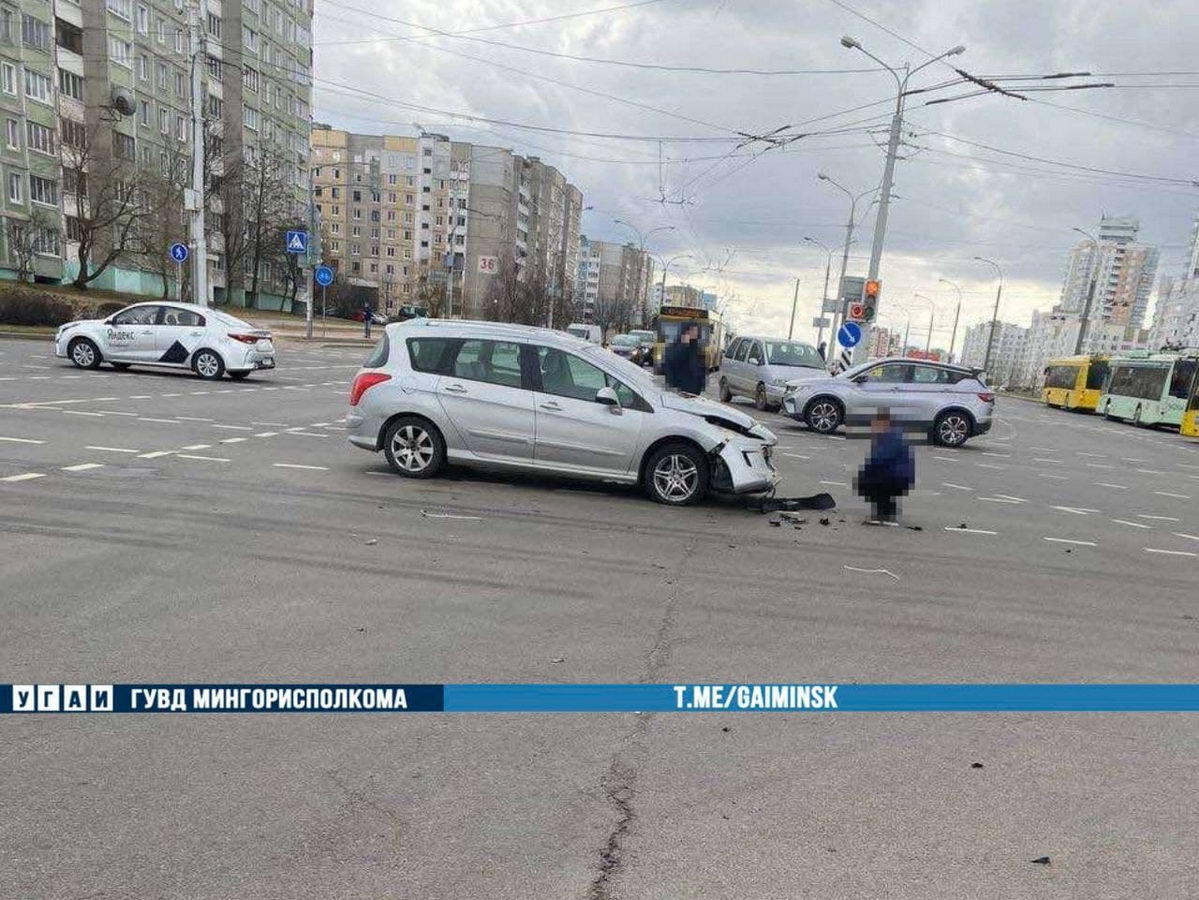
[{"xmin": 719, "ymin": 336, "xmax": 829, "ymax": 410}]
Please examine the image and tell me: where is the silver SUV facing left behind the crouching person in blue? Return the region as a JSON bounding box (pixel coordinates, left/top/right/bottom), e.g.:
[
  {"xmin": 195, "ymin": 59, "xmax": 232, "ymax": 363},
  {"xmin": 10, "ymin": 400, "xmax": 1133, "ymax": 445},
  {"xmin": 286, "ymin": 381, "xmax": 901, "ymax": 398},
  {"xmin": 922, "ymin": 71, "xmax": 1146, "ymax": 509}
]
[{"xmin": 783, "ymin": 358, "xmax": 995, "ymax": 447}]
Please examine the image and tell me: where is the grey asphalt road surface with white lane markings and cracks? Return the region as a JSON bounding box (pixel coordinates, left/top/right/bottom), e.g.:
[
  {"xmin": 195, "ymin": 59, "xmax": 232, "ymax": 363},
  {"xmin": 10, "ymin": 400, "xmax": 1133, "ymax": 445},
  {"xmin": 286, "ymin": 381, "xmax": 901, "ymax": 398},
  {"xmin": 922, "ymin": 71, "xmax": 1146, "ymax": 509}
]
[{"xmin": 0, "ymin": 340, "xmax": 1199, "ymax": 900}]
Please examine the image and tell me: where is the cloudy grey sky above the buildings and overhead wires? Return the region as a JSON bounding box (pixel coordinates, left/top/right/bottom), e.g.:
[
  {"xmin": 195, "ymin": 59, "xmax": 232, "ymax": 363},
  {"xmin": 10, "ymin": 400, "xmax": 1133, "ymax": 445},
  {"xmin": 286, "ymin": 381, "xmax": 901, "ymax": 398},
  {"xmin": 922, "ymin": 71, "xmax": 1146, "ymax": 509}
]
[{"xmin": 315, "ymin": 0, "xmax": 1199, "ymax": 344}]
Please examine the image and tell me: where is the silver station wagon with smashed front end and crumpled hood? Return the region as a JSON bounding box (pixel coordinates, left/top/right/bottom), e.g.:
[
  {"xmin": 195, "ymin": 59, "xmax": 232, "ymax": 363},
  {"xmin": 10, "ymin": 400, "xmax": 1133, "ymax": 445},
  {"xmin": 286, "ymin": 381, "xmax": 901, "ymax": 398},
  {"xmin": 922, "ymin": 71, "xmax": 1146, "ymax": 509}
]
[{"xmin": 345, "ymin": 319, "xmax": 776, "ymax": 506}]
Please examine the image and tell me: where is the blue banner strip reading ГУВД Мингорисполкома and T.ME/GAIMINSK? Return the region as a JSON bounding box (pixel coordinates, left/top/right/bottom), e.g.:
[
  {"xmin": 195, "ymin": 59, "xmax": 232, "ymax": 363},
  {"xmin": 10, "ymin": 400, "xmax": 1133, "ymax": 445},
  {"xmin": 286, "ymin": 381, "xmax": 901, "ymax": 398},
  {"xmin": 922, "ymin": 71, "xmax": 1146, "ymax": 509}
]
[{"xmin": 7, "ymin": 682, "xmax": 1199, "ymax": 715}]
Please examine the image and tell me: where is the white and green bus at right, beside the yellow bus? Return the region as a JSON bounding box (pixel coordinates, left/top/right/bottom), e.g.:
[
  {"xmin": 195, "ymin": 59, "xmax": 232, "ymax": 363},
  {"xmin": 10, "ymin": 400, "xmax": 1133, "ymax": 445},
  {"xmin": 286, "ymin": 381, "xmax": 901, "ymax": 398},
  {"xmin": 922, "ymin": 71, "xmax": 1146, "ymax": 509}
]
[{"xmin": 1097, "ymin": 350, "xmax": 1199, "ymax": 428}]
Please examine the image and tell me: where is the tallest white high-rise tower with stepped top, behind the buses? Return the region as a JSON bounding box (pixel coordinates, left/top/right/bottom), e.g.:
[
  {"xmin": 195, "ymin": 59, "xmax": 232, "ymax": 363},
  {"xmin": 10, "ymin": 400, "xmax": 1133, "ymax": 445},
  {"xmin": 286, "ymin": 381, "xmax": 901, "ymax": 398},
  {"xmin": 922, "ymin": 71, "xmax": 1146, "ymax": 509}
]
[{"xmin": 1058, "ymin": 216, "xmax": 1158, "ymax": 328}]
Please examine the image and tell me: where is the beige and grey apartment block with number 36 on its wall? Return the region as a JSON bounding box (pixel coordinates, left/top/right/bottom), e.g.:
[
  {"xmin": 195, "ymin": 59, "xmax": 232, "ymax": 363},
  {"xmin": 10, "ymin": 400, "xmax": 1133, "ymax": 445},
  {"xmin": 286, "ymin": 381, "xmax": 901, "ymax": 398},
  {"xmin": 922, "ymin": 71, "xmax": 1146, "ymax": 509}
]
[{"xmin": 312, "ymin": 126, "xmax": 583, "ymax": 318}]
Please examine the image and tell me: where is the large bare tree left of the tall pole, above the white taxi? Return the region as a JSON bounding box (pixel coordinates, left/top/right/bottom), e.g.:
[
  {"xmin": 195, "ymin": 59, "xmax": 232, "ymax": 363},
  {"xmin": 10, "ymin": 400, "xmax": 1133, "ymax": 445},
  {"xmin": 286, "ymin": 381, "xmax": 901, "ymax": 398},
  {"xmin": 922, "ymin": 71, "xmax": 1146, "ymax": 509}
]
[{"xmin": 62, "ymin": 123, "xmax": 150, "ymax": 290}]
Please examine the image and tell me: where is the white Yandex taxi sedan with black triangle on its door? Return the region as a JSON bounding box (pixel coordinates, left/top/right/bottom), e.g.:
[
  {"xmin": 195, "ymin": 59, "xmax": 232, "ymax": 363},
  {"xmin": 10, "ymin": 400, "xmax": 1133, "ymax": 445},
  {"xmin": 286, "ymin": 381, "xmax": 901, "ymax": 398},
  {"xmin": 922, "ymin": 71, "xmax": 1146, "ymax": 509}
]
[{"xmin": 54, "ymin": 303, "xmax": 275, "ymax": 379}]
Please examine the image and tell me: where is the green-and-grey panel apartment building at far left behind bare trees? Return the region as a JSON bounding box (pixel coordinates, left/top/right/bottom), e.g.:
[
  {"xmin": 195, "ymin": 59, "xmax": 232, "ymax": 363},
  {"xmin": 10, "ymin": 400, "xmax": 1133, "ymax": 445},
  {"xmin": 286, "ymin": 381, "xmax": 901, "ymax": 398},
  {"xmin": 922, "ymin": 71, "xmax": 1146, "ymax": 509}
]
[{"xmin": 0, "ymin": 0, "xmax": 312, "ymax": 308}]
